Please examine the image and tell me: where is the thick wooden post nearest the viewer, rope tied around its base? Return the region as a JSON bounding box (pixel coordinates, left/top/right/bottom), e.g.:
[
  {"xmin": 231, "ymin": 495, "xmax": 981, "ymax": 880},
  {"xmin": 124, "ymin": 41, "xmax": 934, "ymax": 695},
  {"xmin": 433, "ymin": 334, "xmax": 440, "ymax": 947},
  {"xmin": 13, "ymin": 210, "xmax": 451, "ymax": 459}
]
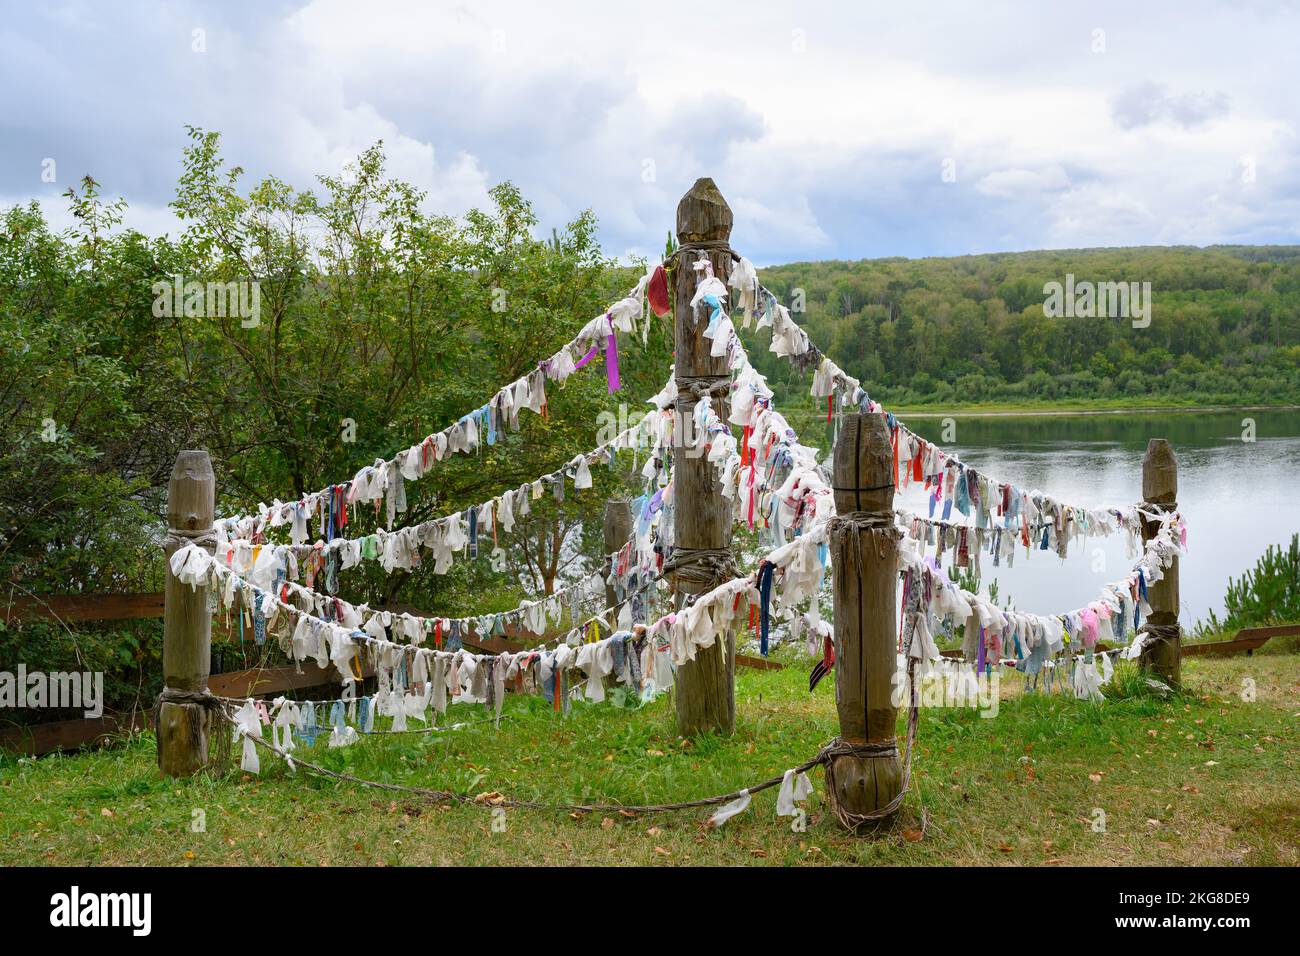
[{"xmin": 827, "ymin": 414, "xmax": 902, "ymax": 827}]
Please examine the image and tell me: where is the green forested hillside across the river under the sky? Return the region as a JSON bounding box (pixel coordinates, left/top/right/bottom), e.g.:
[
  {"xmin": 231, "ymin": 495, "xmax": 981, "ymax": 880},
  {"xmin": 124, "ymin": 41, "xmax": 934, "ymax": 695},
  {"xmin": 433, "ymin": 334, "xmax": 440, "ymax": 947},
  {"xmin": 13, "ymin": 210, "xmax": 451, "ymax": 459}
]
[{"xmin": 759, "ymin": 246, "xmax": 1300, "ymax": 406}]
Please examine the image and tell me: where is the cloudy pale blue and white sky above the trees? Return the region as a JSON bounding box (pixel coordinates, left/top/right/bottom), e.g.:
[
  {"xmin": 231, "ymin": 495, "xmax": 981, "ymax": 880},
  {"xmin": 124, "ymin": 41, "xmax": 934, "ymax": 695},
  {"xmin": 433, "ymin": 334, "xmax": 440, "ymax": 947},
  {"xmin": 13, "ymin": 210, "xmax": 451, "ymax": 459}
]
[{"xmin": 0, "ymin": 0, "xmax": 1300, "ymax": 264}]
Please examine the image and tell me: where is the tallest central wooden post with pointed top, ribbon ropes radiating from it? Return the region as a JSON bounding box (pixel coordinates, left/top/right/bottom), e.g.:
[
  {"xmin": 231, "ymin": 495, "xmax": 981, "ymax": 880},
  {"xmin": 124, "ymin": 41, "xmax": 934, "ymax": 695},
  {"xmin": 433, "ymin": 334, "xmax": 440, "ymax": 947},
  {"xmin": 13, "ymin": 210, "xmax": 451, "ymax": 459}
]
[{"xmin": 666, "ymin": 178, "xmax": 736, "ymax": 736}]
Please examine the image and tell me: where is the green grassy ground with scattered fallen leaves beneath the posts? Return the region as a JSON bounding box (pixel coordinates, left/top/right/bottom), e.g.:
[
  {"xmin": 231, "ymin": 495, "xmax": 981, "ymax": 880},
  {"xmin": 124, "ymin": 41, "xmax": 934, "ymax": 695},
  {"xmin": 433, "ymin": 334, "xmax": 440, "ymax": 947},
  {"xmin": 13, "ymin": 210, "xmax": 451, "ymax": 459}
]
[{"xmin": 0, "ymin": 653, "xmax": 1300, "ymax": 865}]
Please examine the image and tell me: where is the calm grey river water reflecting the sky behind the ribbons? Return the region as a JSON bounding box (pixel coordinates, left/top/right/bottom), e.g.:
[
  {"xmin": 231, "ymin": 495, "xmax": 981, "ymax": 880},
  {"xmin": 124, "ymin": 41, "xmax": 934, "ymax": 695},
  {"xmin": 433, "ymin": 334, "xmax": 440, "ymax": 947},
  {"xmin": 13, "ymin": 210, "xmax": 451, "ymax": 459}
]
[{"xmin": 897, "ymin": 411, "xmax": 1300, "ymax": 628}]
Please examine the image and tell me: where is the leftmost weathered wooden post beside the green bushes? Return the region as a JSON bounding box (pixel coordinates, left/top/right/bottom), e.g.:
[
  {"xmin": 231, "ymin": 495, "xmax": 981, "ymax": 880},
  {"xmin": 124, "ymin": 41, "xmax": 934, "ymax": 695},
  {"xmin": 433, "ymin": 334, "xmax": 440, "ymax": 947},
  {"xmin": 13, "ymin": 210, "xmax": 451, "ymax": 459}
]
[{"xmin": 156, "ymin": 451, "xmax": 217, "ymax": 777}]
